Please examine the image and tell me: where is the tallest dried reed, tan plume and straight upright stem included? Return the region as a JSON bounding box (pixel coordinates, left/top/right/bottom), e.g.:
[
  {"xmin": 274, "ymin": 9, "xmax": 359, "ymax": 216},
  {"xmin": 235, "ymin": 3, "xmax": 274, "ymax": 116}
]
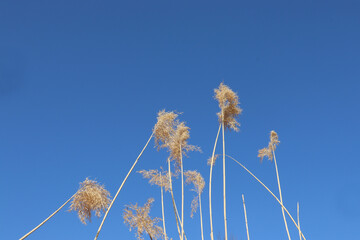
[{"xmin": 214, "ymin": 83, "xmax": 242, "ymax": 240}]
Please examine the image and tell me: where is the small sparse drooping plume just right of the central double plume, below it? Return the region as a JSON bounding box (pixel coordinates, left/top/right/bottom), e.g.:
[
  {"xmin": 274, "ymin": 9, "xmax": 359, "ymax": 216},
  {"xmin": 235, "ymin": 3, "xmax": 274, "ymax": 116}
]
[{"xmin": 184, "ymin": 170, "xmax": 205, "ymax": 217}]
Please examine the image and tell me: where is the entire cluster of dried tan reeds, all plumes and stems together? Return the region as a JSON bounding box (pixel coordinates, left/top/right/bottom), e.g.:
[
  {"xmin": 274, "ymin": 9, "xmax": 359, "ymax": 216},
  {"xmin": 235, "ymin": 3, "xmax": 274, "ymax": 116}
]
[{"xmin": 20, "ymin": 83, "xmax": 306, "ymax": 240}]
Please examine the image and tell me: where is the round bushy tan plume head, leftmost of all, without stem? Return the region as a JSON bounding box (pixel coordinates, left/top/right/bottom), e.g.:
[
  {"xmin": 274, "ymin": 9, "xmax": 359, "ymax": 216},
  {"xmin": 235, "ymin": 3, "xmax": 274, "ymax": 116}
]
[{"xmin": 69, "ymin": 178, "xmax": 111, "ymax": 225}]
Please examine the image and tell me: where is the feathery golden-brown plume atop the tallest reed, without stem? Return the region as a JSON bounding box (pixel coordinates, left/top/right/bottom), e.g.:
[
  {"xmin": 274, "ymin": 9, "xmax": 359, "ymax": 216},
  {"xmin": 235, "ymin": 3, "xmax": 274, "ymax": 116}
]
[{"xmin": 214, "ymin": 83, "xmax": 242, "ymax": 131}]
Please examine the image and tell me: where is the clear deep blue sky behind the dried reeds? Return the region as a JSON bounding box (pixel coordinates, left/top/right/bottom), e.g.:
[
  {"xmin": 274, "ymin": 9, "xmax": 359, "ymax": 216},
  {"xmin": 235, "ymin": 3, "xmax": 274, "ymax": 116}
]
[{"xmin": 0, "ymin": 0, "xmax": 360, "ymax": 240}]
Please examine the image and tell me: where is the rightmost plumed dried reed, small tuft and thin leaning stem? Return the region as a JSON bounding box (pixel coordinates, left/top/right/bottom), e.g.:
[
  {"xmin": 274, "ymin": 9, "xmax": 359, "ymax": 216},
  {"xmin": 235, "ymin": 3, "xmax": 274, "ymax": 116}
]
[{"xmin": 258, "ymin": 131, "xmax": 291, "ymax": 240}]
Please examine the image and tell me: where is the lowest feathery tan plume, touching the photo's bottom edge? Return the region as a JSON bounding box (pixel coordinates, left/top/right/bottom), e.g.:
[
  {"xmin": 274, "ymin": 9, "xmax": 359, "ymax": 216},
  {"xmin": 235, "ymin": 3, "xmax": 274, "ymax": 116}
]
[{"xmin": 123, "ymin": 198, "xmax": 163, "ymax": 240}]
